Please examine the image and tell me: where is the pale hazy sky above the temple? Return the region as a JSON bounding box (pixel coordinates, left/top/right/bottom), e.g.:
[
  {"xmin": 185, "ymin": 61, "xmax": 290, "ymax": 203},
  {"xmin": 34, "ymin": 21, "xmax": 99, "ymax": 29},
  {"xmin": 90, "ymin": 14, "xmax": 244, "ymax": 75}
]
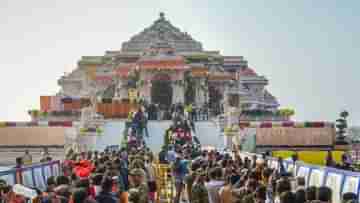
[{"xmin": 0, "ymin": 0, "xmax": 360, "ymax": 125}]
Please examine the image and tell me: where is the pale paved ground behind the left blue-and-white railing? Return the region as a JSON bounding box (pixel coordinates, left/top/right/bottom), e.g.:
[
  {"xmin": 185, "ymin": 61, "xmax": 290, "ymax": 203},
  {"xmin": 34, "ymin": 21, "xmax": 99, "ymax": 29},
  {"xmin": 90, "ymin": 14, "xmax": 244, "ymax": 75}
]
[{"xmin": 0, "ymin": 148, "xmax": 64, "ymax": 166}]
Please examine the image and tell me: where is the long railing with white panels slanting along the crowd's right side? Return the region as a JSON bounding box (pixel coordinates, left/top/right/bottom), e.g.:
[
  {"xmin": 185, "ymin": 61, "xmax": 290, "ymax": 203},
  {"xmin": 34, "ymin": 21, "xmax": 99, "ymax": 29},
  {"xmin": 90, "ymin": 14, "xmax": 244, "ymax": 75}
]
[{"xmin": 240, "ymin": 152, "xmax": 360, "ymax": 202}]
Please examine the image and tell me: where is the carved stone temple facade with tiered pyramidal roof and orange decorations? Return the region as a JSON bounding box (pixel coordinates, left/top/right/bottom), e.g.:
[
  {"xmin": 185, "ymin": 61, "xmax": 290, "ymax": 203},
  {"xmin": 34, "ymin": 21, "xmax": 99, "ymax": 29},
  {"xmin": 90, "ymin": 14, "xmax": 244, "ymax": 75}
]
[{"xmin": 50, "ymin": 13, "xmax": 279, "ymax": 120}]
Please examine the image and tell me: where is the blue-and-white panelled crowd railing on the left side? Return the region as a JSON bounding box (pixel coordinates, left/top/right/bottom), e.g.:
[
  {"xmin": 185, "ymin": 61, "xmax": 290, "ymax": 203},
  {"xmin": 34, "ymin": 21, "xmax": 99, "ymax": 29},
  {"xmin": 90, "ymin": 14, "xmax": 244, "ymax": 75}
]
[{"xmin": 0, "ymin": 161, "xmax": 61, "ymax": 190}]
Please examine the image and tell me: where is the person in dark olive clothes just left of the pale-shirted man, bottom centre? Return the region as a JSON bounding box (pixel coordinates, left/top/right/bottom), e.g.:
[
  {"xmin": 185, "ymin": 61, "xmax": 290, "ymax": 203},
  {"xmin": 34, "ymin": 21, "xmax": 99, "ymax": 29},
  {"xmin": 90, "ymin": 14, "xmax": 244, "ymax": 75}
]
[{"xmin": 191, "ymin": 169, "xmax": 209, "ymax": 203}]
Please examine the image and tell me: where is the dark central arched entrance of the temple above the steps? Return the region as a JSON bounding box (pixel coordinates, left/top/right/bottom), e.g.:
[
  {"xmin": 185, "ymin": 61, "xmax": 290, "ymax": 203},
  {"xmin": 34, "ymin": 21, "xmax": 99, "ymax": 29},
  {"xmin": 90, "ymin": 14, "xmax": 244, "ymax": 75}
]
[{"xmin": 151, "ymin": 74, "xmax": 173, "ymax": 108}]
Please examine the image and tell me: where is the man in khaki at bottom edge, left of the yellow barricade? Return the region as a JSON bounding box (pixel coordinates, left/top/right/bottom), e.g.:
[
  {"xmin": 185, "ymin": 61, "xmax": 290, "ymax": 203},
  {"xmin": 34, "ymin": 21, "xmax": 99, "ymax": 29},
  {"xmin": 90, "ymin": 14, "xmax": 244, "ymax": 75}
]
[{"xmin": 129, "ymin": 168, "xmax": 149, "ymax": 203}]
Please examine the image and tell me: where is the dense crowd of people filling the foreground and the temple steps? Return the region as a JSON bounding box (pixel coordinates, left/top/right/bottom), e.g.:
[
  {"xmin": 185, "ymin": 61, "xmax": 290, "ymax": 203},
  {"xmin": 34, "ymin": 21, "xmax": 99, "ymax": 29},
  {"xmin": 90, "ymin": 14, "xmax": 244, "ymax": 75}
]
[{"xmin": 0, "ymin": 105, "xmax": 358, "ymax": 203}]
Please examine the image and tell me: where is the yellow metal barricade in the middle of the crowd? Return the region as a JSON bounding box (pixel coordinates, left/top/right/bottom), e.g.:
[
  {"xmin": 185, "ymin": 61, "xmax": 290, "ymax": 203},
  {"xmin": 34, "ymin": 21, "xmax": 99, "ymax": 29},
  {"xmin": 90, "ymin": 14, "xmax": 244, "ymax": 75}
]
[{"xmin": 156, "ymin": 164, "xmax": 175, "ymax": 203}]
